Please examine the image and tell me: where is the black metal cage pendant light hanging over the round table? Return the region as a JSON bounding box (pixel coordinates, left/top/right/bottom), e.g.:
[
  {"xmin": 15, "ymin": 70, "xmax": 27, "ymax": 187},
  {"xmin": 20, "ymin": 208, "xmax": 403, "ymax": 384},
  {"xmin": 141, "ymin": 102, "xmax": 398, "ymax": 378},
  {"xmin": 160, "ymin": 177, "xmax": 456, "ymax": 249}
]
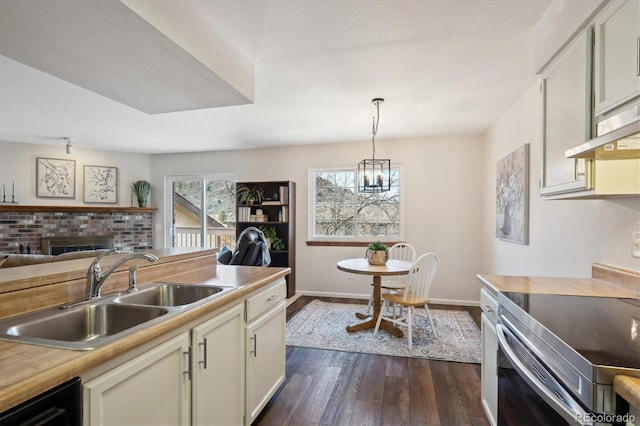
[{"xmin": 358, "ymin": 98, "xmax": 391, "ymax": 192}]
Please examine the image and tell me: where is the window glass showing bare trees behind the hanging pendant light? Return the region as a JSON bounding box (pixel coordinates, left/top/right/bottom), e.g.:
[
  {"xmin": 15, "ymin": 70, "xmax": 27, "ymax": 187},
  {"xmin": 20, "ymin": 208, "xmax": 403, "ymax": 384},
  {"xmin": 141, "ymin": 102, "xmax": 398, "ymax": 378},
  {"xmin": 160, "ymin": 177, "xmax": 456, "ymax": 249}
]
[{"xmin": 312, "ymin": 167, "xmax": 400, "ymax": 239}]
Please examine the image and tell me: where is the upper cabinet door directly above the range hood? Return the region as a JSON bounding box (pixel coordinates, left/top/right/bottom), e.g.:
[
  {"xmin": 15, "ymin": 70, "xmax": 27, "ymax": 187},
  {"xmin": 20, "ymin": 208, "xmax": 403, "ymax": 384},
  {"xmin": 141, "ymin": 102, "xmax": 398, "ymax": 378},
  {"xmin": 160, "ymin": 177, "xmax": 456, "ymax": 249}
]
[{"xmin": 594, "ymin": 0, "xmax": 640, "ymax": 116}]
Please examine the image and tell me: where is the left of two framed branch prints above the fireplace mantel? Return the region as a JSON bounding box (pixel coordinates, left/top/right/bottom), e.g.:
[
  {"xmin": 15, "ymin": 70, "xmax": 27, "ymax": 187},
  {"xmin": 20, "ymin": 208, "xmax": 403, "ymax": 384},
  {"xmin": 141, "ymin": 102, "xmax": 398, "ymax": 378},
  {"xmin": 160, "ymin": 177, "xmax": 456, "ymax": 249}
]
[{"xmin": 36, "ymin": 157, "xmax": 76, "ymax": 198}]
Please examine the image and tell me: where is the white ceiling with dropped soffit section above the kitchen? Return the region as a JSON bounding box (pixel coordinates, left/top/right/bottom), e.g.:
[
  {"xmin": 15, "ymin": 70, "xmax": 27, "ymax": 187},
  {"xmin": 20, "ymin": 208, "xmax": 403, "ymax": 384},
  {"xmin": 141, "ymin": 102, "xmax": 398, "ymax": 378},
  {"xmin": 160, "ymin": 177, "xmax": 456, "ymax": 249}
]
[{"xmin": 0, "ymin": 0, "xmax": 558, "ymax": 153}]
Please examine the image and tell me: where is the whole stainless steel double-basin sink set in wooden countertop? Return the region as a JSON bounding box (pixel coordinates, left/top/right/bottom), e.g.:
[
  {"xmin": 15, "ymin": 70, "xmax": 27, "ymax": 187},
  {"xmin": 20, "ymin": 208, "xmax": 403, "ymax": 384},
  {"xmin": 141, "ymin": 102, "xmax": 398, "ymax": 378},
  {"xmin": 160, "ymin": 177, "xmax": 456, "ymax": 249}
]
[{"xmin": 0, "ymin": 283, "xmax": 236, "ymax": 350}]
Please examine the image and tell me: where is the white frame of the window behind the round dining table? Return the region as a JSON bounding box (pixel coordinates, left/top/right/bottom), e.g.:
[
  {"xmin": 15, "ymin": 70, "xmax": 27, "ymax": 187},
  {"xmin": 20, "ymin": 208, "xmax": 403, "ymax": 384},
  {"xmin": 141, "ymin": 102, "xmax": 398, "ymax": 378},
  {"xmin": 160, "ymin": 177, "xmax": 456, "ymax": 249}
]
[{"xmin": 307, "ymin": 164, "xmax": 405, "ymax": 242}]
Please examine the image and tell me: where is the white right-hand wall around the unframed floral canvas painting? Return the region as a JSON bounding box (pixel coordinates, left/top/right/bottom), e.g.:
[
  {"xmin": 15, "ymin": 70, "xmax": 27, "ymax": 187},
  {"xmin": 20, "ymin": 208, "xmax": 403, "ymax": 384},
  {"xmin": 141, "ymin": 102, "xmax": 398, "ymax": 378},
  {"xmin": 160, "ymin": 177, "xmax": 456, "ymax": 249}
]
[{"xmin": 482, "ymin": 84, "xmax": 640, "ymax": 277}]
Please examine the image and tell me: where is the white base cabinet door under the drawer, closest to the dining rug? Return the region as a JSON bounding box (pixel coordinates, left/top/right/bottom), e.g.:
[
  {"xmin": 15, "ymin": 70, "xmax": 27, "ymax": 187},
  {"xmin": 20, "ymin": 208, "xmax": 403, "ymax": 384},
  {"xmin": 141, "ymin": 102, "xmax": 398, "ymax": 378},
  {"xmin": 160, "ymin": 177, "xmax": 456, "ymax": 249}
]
[{"xmin": 245, "ymin": 300, "xmax": 286, "ymax": 424}]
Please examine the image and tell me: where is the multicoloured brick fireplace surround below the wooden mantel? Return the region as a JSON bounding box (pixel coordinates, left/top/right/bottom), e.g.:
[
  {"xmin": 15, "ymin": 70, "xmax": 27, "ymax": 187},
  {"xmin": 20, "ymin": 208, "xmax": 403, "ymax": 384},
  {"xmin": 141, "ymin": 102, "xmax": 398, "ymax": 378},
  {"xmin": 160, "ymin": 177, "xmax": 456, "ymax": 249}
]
[{"xmin": 0, "ymin": 212, "xmax": 153, "ymax": 253}]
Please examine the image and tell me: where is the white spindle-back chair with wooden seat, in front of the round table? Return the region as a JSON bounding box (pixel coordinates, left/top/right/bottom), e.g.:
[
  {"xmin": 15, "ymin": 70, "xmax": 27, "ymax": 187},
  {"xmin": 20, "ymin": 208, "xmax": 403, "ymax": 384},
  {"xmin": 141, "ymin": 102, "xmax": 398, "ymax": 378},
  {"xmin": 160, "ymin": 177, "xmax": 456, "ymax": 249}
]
[{"xmin": 373, "ymin": 252, "xmax": 439, "ymax": 350}]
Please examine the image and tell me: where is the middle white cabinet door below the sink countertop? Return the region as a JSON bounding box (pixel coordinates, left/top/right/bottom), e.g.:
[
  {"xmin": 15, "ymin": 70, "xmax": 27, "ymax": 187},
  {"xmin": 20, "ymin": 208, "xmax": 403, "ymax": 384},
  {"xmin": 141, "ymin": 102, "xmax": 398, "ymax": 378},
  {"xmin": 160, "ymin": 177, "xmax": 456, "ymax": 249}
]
[{"xmin": 192, "ymin": 303, "xmax": 245, "ymax": 425}]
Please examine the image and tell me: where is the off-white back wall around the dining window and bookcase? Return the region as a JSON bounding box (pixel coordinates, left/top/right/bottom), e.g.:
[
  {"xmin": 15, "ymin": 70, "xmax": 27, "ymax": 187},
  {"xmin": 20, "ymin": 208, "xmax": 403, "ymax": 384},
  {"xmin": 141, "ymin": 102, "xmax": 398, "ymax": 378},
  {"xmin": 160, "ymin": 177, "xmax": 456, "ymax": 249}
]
[{"xmin": 152, "ymin": 136, "xmax": 483, "ymax": 303}]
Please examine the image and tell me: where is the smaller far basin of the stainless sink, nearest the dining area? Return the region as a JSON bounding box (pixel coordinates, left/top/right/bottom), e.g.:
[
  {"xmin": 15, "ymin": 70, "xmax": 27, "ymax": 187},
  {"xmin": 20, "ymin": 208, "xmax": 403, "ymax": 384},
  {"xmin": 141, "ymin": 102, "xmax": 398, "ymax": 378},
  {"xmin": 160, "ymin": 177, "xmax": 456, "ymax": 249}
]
[{"xmin": 116, "ymin": 283, "xmax": 234, "ymax": 307}]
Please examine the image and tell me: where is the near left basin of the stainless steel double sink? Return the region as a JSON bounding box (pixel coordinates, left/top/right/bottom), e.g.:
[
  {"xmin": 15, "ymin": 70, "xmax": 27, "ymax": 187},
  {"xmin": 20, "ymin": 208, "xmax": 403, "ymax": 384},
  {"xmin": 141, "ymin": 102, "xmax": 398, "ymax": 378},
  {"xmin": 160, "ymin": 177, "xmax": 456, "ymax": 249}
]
[{"xmin": 0, "ymin": 301, "xmax": 170, "ymax": 350}]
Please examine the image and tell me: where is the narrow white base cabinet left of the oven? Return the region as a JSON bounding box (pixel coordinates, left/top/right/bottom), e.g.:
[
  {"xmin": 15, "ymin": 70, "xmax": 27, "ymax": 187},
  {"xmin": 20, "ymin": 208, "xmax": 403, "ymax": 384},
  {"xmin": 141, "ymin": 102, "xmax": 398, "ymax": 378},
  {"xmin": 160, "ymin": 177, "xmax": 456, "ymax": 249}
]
[{"xmin": 480, "ymin": 289, "xmax": 498, "ymax": 426}]
